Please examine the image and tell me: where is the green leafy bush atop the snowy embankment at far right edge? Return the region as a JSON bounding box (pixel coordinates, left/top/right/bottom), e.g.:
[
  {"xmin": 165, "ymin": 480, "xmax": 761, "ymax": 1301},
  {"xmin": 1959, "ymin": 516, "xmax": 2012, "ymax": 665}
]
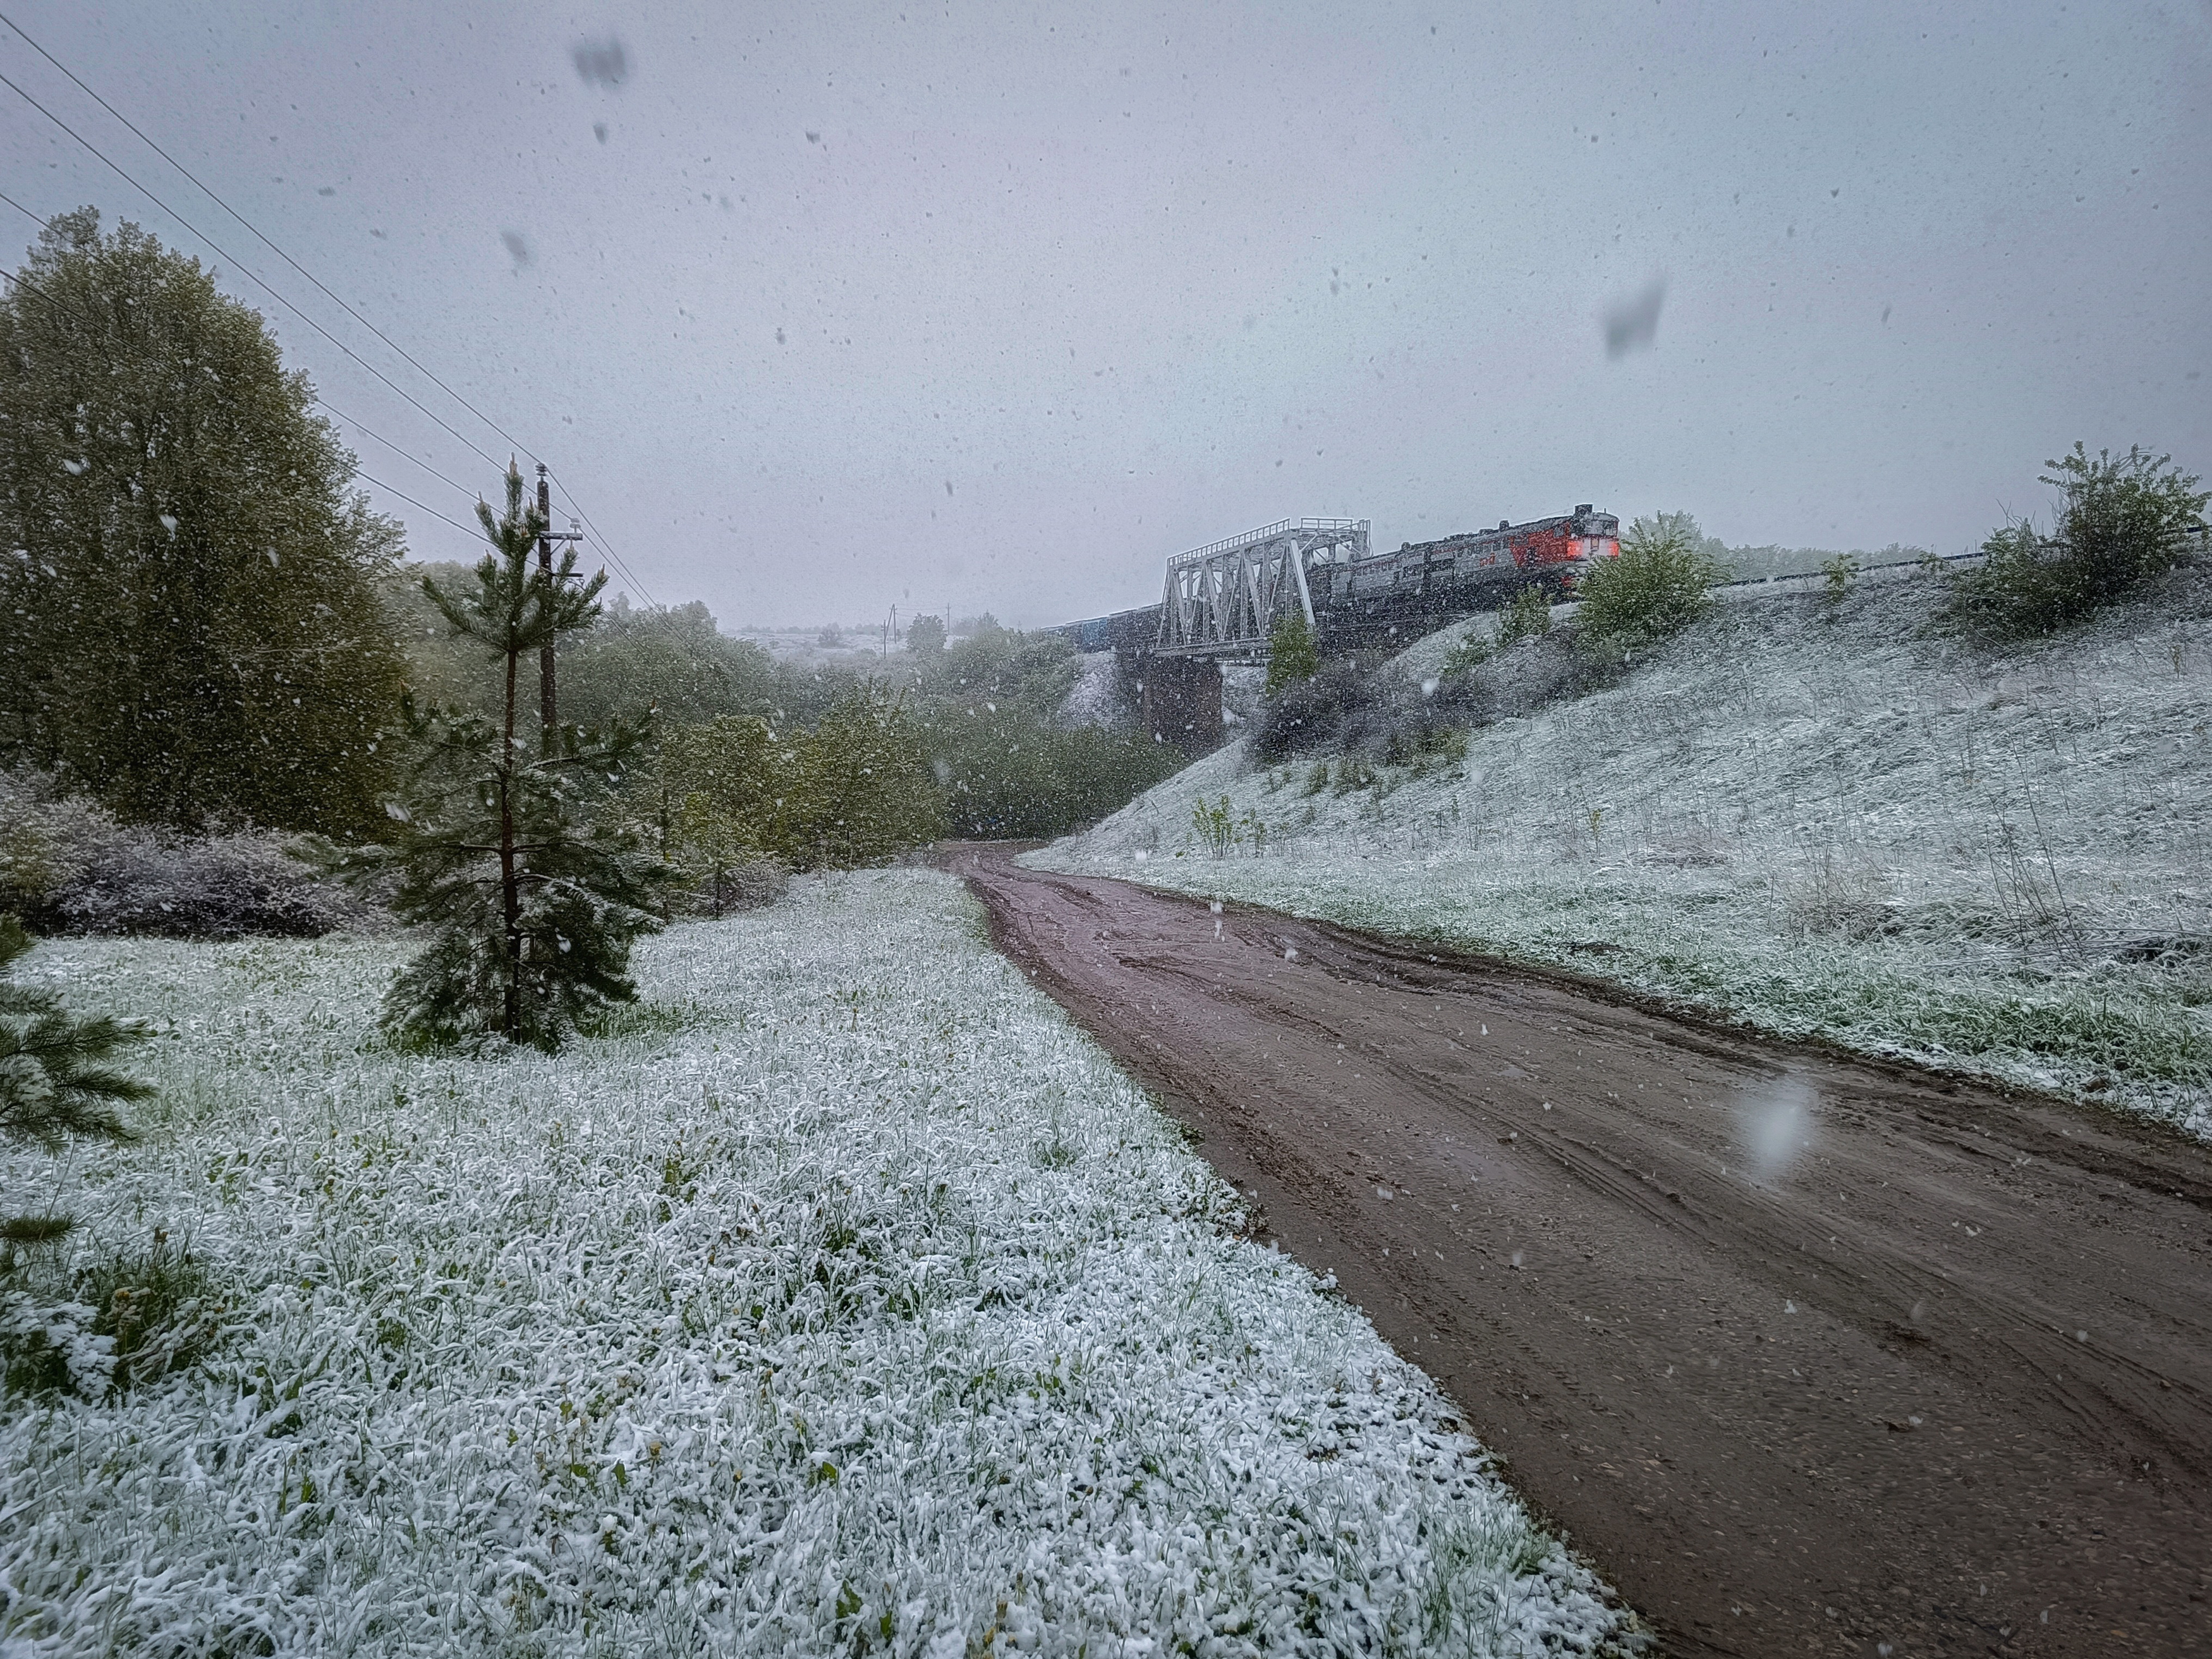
[{"xmin": 1945, "ymin": 442, "xmax": 2212, "ymax": 640}]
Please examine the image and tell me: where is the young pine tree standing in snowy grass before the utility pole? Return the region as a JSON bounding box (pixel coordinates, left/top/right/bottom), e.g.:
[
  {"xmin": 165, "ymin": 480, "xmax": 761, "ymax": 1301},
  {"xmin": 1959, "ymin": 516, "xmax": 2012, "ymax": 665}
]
[{"xmin": 367, "ymin": 469, "xmax": 662, "ymax": 1053}]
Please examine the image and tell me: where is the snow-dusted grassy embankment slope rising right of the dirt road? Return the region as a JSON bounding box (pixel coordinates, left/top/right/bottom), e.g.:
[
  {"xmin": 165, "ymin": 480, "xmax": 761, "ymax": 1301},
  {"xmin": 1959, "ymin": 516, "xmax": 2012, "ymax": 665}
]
[{"xmin": 1029, "ymin": 569, "xmax": 2212, "ymax": 1135}]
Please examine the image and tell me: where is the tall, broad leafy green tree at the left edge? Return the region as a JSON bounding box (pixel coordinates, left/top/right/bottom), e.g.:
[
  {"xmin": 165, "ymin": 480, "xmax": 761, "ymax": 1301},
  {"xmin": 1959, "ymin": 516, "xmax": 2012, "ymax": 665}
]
[{"xmin": 0, "ymin": 208, "xmax": 401, "ymax": 832}]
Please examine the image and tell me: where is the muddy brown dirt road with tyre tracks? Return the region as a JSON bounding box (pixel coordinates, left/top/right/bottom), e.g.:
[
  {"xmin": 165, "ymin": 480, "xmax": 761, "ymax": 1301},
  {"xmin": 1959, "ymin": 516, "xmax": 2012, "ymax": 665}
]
[{"xmin": 947, "ymin": 848, "xmax": 2212, "ymax": 1659}]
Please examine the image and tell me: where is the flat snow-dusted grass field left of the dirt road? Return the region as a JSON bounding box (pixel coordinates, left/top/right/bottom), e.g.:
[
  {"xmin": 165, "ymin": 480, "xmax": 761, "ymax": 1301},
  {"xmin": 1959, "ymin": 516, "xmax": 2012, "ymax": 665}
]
[{"xmin": 0, "ymin": 872, "xmax": 1632, "ymax": 1659}]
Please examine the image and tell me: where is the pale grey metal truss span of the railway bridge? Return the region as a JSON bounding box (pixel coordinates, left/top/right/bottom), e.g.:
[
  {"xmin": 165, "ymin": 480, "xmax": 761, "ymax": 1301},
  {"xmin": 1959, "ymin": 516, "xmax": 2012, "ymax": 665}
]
[{"xmin": 1153, "ymin": 518, "xmax": 1367, "ymax": 662}]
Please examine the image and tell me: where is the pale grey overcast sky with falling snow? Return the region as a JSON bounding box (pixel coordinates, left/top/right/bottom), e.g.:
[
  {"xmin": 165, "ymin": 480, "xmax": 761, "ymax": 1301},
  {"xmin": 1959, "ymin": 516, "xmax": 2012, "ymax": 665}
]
[{"xmin": 0, "ymin": 0, "xmax": 2212, "ymax": 628}]
